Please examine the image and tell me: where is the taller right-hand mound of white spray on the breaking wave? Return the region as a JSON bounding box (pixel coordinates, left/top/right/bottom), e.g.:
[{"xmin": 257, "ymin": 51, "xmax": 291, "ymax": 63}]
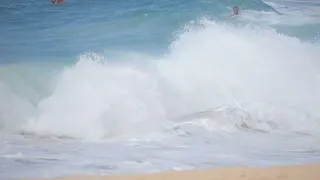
[{"xmin": 163, "ymin": 21, "xmax": 320, "ymax": 134}]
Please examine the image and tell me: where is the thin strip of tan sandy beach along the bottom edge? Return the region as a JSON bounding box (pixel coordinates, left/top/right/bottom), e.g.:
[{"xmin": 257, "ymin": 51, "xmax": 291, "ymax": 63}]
[{"xmin": 24, "ymin": 164, "xmax": 320, "ymax": 180}]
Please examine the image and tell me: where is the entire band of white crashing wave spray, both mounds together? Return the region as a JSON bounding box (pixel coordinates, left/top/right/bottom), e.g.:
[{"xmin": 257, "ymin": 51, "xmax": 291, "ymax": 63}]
[{"xmin": 0, "ymin": 19, "xmax": 320, "ymax": 139}]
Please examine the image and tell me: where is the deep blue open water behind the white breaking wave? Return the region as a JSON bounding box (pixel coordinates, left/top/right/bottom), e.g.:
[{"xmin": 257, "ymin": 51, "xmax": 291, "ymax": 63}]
[{"xmin": 0, "ymin": 0, "xmax": 319, "ymax": 62}]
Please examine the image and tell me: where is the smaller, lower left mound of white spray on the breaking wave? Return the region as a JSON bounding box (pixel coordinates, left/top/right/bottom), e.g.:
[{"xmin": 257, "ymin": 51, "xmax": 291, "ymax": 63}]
[{"xmin": 23, "ymin": 52, "xmax": 163, "ymax": 139}]
